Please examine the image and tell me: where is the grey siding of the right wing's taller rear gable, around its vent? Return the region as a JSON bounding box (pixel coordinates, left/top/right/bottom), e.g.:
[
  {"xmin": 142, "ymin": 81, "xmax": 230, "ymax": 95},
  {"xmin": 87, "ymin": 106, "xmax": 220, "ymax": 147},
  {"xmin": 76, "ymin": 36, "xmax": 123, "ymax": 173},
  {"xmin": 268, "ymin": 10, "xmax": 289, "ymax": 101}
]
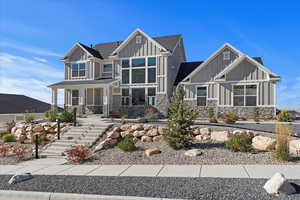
[{"xmin": 191, "ymin": 48, "xmax": 238, "ymax": 82}]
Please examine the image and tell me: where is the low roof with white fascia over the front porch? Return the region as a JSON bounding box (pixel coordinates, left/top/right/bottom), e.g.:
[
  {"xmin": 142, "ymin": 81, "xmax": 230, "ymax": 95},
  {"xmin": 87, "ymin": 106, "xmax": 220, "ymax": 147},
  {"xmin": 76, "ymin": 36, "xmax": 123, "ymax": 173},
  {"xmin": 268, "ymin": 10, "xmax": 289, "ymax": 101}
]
[{"xmin": 48, "ymin": 79, "xmax": 117, "ymax": 88}]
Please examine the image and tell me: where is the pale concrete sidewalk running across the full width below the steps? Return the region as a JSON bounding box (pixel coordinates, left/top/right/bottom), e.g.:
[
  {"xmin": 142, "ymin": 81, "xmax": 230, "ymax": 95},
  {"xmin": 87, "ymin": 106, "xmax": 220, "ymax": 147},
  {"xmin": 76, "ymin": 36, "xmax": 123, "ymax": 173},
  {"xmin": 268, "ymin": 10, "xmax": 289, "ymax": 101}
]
[{"xmin": 0, "ymin": 162, "xmax": 300, "ymax": 179}]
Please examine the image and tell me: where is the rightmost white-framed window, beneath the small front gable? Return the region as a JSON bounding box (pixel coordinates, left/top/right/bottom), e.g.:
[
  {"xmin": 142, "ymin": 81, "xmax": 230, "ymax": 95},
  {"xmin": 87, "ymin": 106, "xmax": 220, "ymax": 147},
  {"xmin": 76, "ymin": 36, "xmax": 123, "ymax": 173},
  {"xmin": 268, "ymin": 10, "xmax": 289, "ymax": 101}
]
[{"xmin": 233, "ymin": 85, "xmax": 257, "ymax": 106}]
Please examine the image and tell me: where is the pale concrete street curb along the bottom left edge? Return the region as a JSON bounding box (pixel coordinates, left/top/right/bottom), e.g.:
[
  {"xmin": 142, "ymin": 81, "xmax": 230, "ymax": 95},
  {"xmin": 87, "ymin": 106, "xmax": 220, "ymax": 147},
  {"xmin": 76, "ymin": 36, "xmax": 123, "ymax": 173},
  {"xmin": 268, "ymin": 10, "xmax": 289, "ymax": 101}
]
[{"xmin": 0, "ymin": 190, "xmax": 176, "ymax": 200}]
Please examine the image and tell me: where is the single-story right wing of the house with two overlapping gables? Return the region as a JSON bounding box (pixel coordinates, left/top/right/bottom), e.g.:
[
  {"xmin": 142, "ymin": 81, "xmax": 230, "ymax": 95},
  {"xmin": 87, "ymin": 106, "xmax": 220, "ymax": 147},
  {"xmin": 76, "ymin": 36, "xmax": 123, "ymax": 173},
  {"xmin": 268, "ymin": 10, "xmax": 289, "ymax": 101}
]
[{"xmin": 177, "ymin": 43, "xmax": 280, "ymax": 118}]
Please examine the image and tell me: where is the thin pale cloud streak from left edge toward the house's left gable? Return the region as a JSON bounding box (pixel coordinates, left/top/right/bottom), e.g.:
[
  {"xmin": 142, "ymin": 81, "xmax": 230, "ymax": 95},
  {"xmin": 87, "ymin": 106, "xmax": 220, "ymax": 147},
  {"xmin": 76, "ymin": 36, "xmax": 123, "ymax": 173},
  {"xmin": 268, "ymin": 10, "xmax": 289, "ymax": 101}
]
[{"xmin": 0, "ymin": 41, "xmax": 63, "ymax": 57}]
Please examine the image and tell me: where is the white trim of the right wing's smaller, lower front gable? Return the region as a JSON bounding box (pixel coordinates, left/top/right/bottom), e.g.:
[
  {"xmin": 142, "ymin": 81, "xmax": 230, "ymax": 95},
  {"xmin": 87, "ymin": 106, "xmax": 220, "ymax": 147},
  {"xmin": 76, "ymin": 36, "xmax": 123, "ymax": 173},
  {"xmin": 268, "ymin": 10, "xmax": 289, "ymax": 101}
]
[{"xmin": 215, "ymin": 54, "xmax": 280, "ymax": 80}]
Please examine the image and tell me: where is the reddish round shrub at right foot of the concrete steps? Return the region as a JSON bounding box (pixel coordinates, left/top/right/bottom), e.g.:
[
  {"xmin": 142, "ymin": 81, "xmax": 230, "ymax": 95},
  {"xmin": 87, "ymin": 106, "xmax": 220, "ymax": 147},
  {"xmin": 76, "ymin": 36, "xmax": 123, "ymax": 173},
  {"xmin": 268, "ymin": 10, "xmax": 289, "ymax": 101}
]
[{"xmin": 67, "ymin": 145, "xmax": 91, "ymax": 163}]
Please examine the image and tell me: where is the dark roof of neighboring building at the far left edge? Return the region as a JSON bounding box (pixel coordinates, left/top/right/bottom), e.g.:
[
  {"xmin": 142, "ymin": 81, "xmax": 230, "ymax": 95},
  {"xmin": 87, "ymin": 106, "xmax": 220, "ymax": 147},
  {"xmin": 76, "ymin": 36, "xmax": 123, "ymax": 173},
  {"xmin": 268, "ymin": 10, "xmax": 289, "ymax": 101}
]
[{"xmin": 0, "ymin": 93, "xmax": 51, "ymax": 114}]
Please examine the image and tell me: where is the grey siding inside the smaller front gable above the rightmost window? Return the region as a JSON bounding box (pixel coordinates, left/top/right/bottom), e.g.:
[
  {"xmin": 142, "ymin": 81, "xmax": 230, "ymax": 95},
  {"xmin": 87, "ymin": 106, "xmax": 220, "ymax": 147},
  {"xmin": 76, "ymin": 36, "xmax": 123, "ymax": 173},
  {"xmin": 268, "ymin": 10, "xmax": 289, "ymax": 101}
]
[{"xmin": 226, "ymin": 60, "xmax": 267, "ymax": 81}]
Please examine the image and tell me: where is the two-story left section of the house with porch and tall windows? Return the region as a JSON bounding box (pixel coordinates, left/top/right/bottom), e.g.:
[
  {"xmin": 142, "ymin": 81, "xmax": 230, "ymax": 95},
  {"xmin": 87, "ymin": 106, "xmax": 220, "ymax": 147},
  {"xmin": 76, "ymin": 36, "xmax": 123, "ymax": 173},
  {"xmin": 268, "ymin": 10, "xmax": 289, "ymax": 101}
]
[{"xmin": 49, "ymin": 29, "xmax": 186, "ymax": 115}]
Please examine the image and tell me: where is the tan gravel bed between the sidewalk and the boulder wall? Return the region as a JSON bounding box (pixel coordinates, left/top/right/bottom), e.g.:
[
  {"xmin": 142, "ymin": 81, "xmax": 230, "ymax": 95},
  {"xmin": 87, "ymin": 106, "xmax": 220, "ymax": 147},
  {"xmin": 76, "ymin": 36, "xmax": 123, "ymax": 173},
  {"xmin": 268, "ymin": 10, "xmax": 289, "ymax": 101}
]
[{"xmin": 84, "ymin": 126, "xmax": 300, "ymax": 165}]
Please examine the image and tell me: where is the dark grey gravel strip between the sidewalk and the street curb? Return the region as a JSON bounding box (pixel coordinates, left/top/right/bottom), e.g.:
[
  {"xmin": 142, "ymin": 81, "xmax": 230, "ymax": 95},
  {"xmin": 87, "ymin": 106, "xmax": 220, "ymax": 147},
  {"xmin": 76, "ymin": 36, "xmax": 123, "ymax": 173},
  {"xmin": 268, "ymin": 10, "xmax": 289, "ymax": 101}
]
[{"xmin": 0, "ymin": 175, "xmax": 300, "ymax": 200}]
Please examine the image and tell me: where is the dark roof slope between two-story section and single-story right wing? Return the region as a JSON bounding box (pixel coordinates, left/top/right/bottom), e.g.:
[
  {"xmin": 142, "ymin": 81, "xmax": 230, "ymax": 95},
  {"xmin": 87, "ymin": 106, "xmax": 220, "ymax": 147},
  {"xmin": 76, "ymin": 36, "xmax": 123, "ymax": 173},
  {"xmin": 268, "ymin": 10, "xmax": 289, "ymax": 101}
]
[{"xmin": 174, "ymin": 61, "xmax": 203, "ymax": 86}]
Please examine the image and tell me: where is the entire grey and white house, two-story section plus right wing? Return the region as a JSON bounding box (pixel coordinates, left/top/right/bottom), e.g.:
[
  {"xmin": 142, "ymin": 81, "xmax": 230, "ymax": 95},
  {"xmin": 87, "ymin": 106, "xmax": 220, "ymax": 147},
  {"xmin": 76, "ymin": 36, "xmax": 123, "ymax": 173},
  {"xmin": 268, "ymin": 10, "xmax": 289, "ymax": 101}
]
[{"xmin": 49, "ymin": 29, "xmax": 280, "ymax": 118}]
